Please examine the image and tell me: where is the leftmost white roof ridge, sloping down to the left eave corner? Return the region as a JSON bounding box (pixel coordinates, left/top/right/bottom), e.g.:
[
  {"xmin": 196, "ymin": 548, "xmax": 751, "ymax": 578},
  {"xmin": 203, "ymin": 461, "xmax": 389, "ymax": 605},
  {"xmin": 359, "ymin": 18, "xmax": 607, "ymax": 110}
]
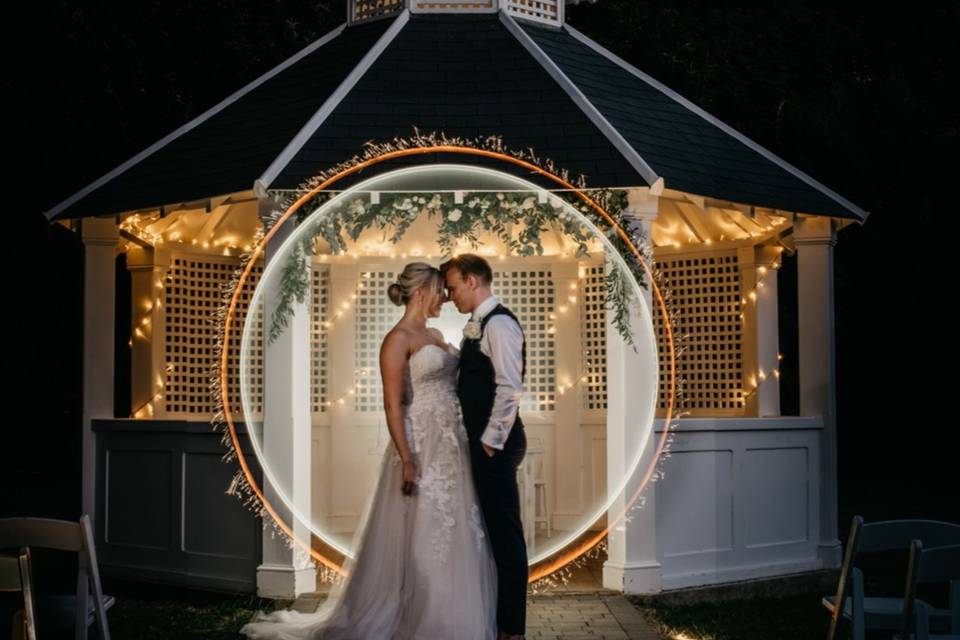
[{"xmin": 44, "ymin": 22, "xmax": 347, "ymax": 221}]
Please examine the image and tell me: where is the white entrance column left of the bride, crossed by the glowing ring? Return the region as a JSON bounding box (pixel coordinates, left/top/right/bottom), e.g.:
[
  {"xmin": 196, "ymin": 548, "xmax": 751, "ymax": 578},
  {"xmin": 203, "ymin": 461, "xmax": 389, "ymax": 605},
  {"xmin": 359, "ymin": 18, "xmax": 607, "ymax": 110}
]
[{"xmin": 257, "ymin": 198, "xmax": 317, "ymax": 599}]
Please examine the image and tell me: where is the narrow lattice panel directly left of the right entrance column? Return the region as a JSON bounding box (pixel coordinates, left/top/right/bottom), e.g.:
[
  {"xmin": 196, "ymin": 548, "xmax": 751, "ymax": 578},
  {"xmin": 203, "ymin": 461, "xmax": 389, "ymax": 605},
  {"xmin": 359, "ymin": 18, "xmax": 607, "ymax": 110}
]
[{"xmin": 580, "ymin": 263, "xmax": 607, "ymax": 409}]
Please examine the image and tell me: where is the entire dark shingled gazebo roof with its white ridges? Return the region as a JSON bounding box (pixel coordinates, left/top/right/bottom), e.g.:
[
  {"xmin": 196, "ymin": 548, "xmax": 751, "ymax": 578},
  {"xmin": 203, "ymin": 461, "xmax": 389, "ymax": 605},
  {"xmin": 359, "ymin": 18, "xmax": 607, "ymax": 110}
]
[{"xmin": 47, "ymin": 9, "xmax": 868, "ymax": 223}]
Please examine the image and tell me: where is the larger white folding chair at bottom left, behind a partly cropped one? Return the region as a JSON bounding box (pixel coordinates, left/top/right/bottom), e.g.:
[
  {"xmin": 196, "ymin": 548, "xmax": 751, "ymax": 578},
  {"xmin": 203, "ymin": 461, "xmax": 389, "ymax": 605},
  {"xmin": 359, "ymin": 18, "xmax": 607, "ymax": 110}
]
[{"xmin": 0, "ymin": 515, "xmax": 115, "ymax": 640}]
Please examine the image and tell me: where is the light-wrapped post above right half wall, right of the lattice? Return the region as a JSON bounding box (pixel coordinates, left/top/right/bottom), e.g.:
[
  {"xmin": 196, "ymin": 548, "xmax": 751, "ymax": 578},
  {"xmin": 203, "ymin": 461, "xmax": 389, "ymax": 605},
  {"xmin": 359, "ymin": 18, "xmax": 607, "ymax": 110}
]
[{"xmin": 737, "ymin": 246, "xmax": 780, "ymax": 418}]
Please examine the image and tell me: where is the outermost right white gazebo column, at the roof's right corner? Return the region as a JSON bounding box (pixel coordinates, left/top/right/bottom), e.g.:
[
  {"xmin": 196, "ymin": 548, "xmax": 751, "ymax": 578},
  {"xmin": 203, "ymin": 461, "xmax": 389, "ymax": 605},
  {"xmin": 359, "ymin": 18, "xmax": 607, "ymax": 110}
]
[{"xmin": 793, "ymin": 216, "xmax": 841, "ymax": 568}]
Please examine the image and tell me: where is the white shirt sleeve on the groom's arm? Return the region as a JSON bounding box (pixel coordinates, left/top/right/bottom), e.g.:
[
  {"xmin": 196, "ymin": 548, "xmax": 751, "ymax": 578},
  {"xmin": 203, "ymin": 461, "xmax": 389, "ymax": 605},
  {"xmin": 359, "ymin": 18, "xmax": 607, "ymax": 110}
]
[{"xmin": 480, "ymin": 315, "xmax": 523, "ymax": 450}]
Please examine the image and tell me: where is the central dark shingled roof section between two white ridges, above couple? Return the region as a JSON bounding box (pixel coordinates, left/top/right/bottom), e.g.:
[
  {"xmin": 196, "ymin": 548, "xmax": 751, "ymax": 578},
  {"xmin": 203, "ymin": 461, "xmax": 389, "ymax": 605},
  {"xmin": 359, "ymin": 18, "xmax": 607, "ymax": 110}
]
[{"xmin": 270, "ymin": 14, "xmax": 645, "ymax": 189}]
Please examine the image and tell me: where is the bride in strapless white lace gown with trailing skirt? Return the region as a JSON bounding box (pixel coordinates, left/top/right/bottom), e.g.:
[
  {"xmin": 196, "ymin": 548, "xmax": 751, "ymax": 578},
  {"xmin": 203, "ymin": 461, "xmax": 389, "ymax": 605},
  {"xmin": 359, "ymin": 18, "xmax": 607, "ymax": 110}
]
[{"xmin": 240, "ymin": 262, "xmax": 497, "ymax": 640}]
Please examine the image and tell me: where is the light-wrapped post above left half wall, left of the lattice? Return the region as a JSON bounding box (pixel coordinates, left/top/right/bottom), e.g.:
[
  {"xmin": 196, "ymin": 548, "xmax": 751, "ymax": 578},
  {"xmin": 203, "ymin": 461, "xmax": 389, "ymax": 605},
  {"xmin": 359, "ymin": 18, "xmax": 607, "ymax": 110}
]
[{"xmin": 127, "ymin": 247, "xmax": 170, "ymax": 418}]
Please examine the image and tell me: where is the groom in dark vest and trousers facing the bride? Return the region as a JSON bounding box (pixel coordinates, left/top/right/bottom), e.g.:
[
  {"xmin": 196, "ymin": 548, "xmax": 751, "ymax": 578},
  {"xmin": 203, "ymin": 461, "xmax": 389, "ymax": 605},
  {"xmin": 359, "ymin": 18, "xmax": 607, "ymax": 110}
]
[{"xmin": 440, "ymin": 253, "xmax": 527, "ymax": 640}]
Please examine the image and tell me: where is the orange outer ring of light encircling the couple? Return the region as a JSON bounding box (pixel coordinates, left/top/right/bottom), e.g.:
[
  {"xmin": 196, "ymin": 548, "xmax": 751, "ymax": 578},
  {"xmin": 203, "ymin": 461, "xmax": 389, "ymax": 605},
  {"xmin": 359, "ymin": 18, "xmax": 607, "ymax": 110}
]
[{"xmin": 219, "ymin": 144, "xmax": 676, "ymax": 582}]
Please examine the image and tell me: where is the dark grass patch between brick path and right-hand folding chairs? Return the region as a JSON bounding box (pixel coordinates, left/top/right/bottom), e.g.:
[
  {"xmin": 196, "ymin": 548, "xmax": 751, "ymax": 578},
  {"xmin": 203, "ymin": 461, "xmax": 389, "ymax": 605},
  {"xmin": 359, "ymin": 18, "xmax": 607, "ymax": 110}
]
[{"xmin": 638, "ymin": 594, "xmax": 829, "ymax": 640}]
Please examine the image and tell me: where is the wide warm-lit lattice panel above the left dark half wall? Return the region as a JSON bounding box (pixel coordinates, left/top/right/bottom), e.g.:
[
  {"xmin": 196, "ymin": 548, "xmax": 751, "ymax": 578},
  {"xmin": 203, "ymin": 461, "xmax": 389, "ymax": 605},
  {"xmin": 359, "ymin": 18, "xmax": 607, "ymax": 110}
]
[{"xmin": 160, "ymin": 254, "xmax": 263, "ymax": 420}]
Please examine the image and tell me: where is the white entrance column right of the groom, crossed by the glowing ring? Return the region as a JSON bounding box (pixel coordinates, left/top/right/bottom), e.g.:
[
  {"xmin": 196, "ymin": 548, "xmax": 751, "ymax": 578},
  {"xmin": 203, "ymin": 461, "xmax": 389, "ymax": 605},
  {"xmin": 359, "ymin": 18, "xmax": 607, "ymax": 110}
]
[{"xmin": 603, "ymin": 189, "xmax": 661, "ymax": 593}]
